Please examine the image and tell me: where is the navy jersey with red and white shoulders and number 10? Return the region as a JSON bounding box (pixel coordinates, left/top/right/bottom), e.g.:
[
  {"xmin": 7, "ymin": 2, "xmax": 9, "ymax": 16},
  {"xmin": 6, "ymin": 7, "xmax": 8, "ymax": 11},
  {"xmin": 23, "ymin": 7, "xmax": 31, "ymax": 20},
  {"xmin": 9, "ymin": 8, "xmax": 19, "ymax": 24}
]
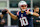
[{"xmin": 17, "ymin": 9, "xmax": 33, "ymax": 27}]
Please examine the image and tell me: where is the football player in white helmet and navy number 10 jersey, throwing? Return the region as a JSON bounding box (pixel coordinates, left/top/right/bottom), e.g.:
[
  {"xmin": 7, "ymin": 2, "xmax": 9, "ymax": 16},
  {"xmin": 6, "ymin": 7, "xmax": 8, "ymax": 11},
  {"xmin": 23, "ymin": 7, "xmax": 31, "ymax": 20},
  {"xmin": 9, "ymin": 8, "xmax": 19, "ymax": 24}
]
[{"xmin": 6, "ymin": 1, "xmax": 39, "ymax": 27}]
